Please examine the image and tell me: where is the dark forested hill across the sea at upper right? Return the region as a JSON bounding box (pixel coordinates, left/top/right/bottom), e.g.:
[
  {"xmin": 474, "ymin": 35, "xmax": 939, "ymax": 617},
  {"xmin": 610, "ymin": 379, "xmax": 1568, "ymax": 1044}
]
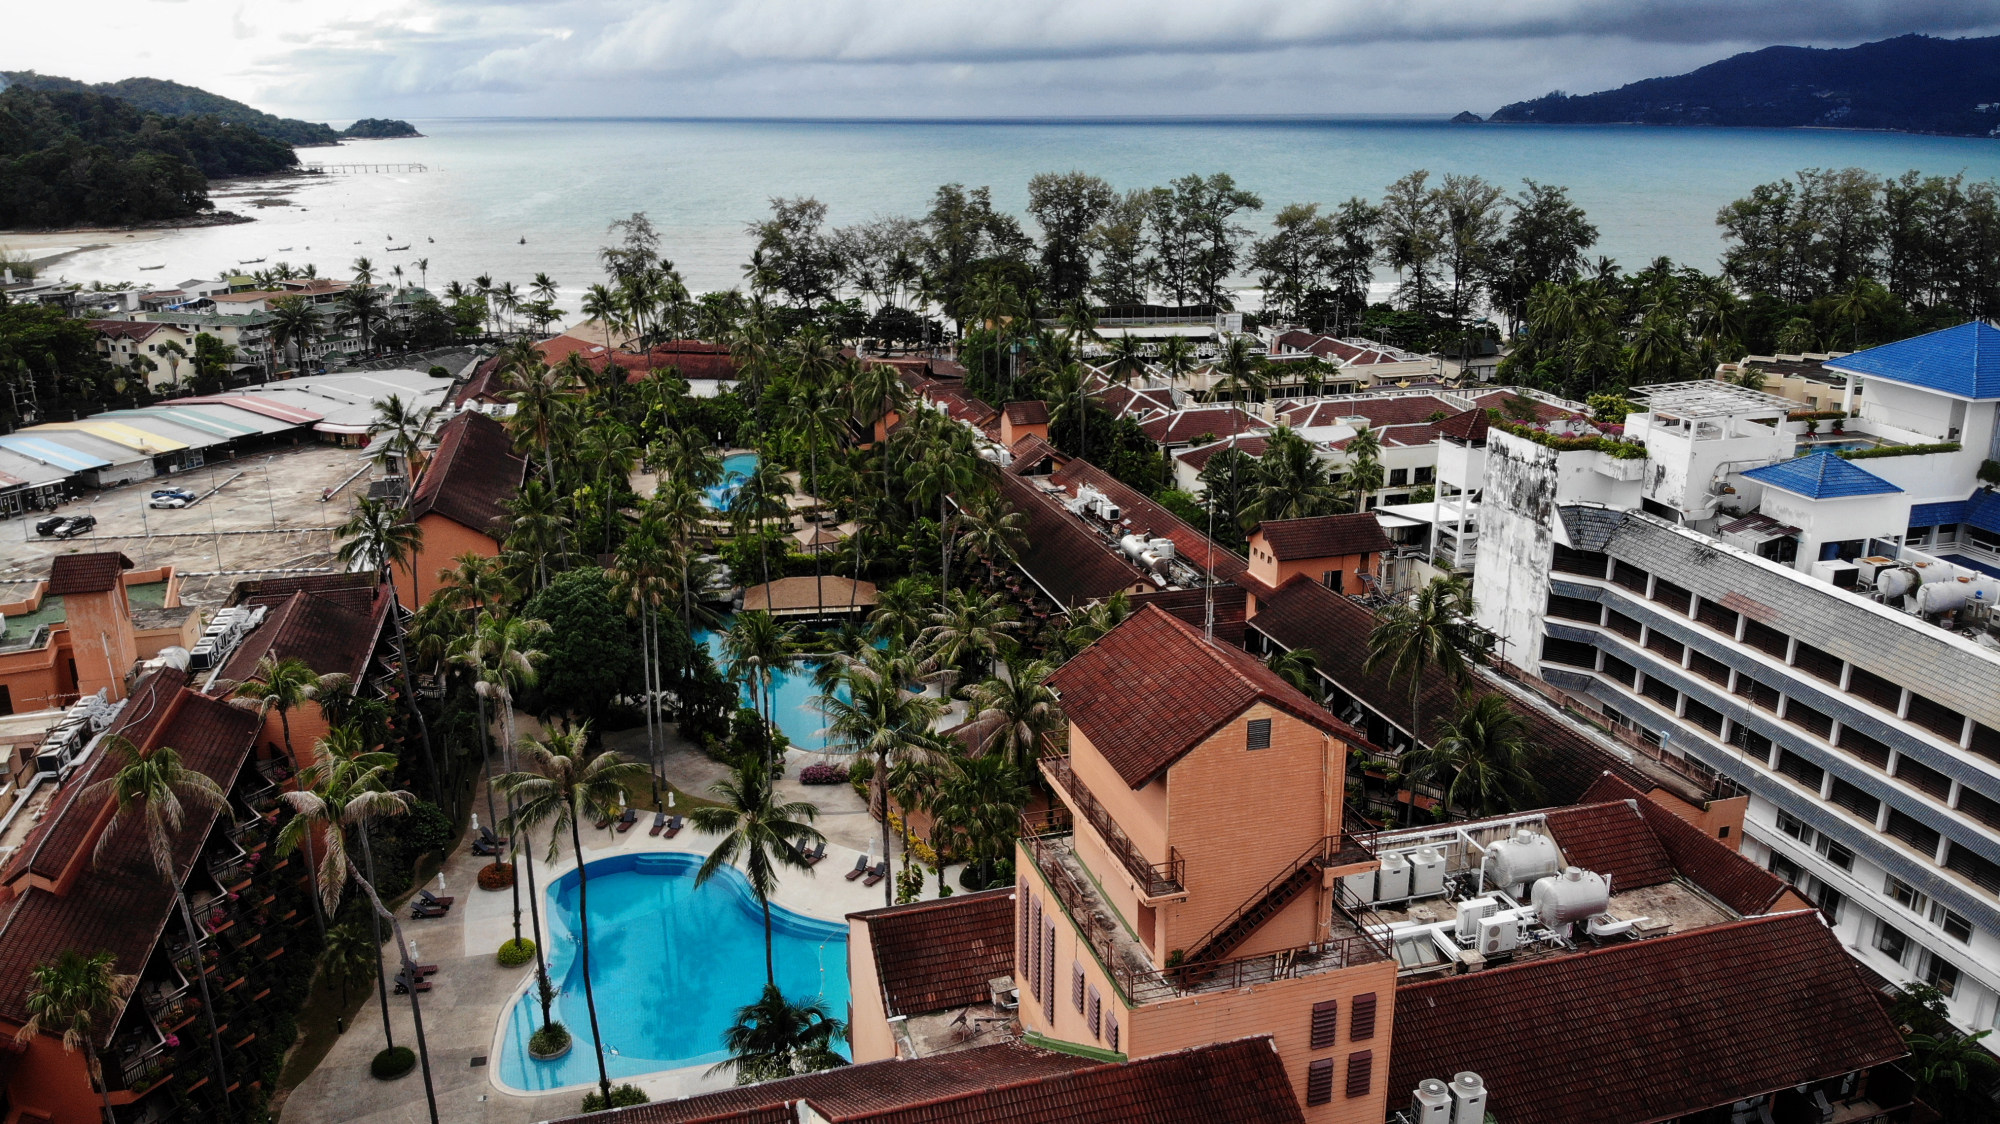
[{"xmin": 1488, "ymin": 36, "xmax": 2000, "ymax": 136}]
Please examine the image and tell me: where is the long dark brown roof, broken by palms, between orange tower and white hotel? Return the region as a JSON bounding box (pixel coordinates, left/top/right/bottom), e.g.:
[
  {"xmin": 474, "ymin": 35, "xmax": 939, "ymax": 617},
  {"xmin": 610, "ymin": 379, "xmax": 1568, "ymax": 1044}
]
[{"xmin": 1250, "ymin": 574, "xmax": 1652, "ymax": 804}]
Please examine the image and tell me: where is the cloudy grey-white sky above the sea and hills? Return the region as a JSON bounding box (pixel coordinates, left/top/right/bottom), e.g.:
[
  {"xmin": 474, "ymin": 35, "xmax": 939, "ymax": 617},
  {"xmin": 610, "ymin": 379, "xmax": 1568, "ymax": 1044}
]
[{"xmin": 0, "ymin": 0, "xmax": 2000, "ymax": 124}]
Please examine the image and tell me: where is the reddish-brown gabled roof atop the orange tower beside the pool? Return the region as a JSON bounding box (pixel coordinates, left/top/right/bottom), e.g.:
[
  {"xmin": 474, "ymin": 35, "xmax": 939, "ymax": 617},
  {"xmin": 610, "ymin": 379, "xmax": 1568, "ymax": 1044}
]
[{"xmin": 1048, "ymin": 606, "xmax": 1352, "ymax": 788}]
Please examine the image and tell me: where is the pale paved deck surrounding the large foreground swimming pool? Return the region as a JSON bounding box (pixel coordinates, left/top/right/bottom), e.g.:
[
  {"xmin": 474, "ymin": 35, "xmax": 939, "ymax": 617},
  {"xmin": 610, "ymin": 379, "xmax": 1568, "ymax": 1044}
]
[{"xmin": 282, "ymin": 718, "xmax": 956, "ymax": 1124}]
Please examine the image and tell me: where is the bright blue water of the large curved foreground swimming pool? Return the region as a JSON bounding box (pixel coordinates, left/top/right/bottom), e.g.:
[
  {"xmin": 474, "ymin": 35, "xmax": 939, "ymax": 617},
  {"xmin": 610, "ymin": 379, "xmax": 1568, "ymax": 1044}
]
[{"xmin": 500, "ymin": 852, "xmax": 848, "ymax": 1092}]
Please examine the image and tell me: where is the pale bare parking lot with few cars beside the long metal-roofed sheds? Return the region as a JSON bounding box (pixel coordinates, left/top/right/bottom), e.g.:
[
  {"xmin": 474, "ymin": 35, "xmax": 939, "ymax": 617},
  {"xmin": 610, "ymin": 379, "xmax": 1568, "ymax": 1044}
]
[{"xmin": 0, "ymin": 446, "xmax": 378, "ymax": 606}]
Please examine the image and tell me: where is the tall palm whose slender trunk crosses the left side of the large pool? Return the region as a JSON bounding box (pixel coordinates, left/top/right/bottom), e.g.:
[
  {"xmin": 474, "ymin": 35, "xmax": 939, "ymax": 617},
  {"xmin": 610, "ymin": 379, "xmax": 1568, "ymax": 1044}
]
[{"xmin": 494, "ymin": 722, "xmax": 646, "ymax": 1104}]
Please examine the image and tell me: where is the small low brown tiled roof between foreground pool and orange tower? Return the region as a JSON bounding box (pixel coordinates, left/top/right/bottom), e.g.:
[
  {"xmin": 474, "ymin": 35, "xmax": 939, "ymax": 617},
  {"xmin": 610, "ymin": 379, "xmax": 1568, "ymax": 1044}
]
[{"xmin": 848, "ymin": 888, "xmax": 1014, "ymax": 1018}]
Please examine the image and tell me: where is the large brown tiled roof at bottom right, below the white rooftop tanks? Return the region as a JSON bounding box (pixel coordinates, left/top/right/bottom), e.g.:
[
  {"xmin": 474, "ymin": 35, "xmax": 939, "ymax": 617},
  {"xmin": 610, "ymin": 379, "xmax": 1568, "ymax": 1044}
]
[{"xmin": 1388, "ymin": 912, "xmax": 1906, "ymax": 1124}]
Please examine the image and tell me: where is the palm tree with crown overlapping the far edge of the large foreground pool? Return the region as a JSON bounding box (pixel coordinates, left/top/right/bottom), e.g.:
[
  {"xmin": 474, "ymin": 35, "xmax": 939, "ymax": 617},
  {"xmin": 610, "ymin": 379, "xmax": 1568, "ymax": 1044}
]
[{"xmin": 688, "ymin": 754, "xmax": 826, "ymax": 988}]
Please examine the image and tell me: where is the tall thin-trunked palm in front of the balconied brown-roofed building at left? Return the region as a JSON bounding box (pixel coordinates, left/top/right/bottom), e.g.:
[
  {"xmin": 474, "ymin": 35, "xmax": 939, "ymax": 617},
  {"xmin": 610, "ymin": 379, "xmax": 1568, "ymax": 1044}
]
[{"xmin": 82, "ymin": 734, "xmax": 230, "ymax": 1088}]
